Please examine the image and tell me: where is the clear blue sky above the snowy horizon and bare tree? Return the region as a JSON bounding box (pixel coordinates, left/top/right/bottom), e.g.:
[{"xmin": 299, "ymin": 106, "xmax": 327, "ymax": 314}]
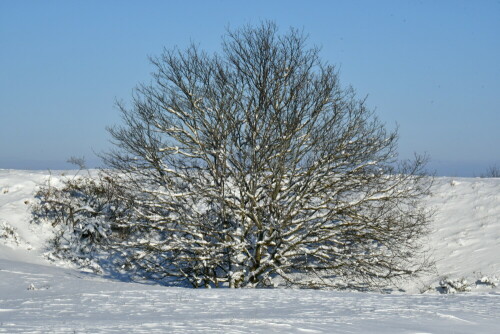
[{"xmin": 0, "ymin": 0, "xmax": 500, "ymax": 176}]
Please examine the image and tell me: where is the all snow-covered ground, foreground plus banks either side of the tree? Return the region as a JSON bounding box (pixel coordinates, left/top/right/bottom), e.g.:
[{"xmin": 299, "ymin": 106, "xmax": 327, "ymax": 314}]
[{"xmin": 0, "ymin": 170, "xmax": 500, "ymax": 333}]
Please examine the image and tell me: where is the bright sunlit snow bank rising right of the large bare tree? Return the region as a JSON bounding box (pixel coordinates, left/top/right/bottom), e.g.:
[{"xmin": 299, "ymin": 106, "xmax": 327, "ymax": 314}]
[{"xmin": 428, "ymin": 178, "xmax": 500, "ymax": 277}]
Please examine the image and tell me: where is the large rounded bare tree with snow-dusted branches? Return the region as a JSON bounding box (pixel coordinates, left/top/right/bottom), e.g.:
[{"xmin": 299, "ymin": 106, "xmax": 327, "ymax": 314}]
[{"xmin": 105, "ymin": 23, "xmax": 430, "ymax": 288}]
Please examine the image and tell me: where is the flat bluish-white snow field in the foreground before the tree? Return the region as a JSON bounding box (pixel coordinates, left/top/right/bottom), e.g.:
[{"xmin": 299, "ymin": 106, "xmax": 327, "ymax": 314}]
[{"xmin": 0, "ymin": 260, "xmax": 500, "ymax": 333}]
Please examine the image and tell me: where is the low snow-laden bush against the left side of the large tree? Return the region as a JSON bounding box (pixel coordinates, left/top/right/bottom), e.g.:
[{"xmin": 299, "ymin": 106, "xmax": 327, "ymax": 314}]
[{"xmin": 31, "ymin": 171, "xmax": 131, "ymax": 271}]
